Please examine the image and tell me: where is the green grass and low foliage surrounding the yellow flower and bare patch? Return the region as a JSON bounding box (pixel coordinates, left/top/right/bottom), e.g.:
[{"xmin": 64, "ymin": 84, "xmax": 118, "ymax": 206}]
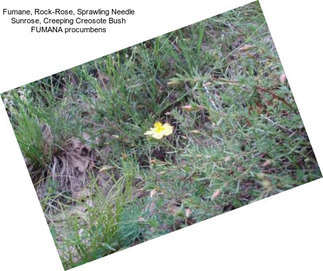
[{"xmin": 2, "ymin": 3, "xmax": 321, "ymax": 269}]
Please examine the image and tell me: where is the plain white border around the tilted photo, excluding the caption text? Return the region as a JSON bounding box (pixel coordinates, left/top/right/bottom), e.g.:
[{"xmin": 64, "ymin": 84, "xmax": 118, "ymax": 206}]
[{"xmin": 0, "ymin": 0, "xmax": 323, "ymax": 271}]
